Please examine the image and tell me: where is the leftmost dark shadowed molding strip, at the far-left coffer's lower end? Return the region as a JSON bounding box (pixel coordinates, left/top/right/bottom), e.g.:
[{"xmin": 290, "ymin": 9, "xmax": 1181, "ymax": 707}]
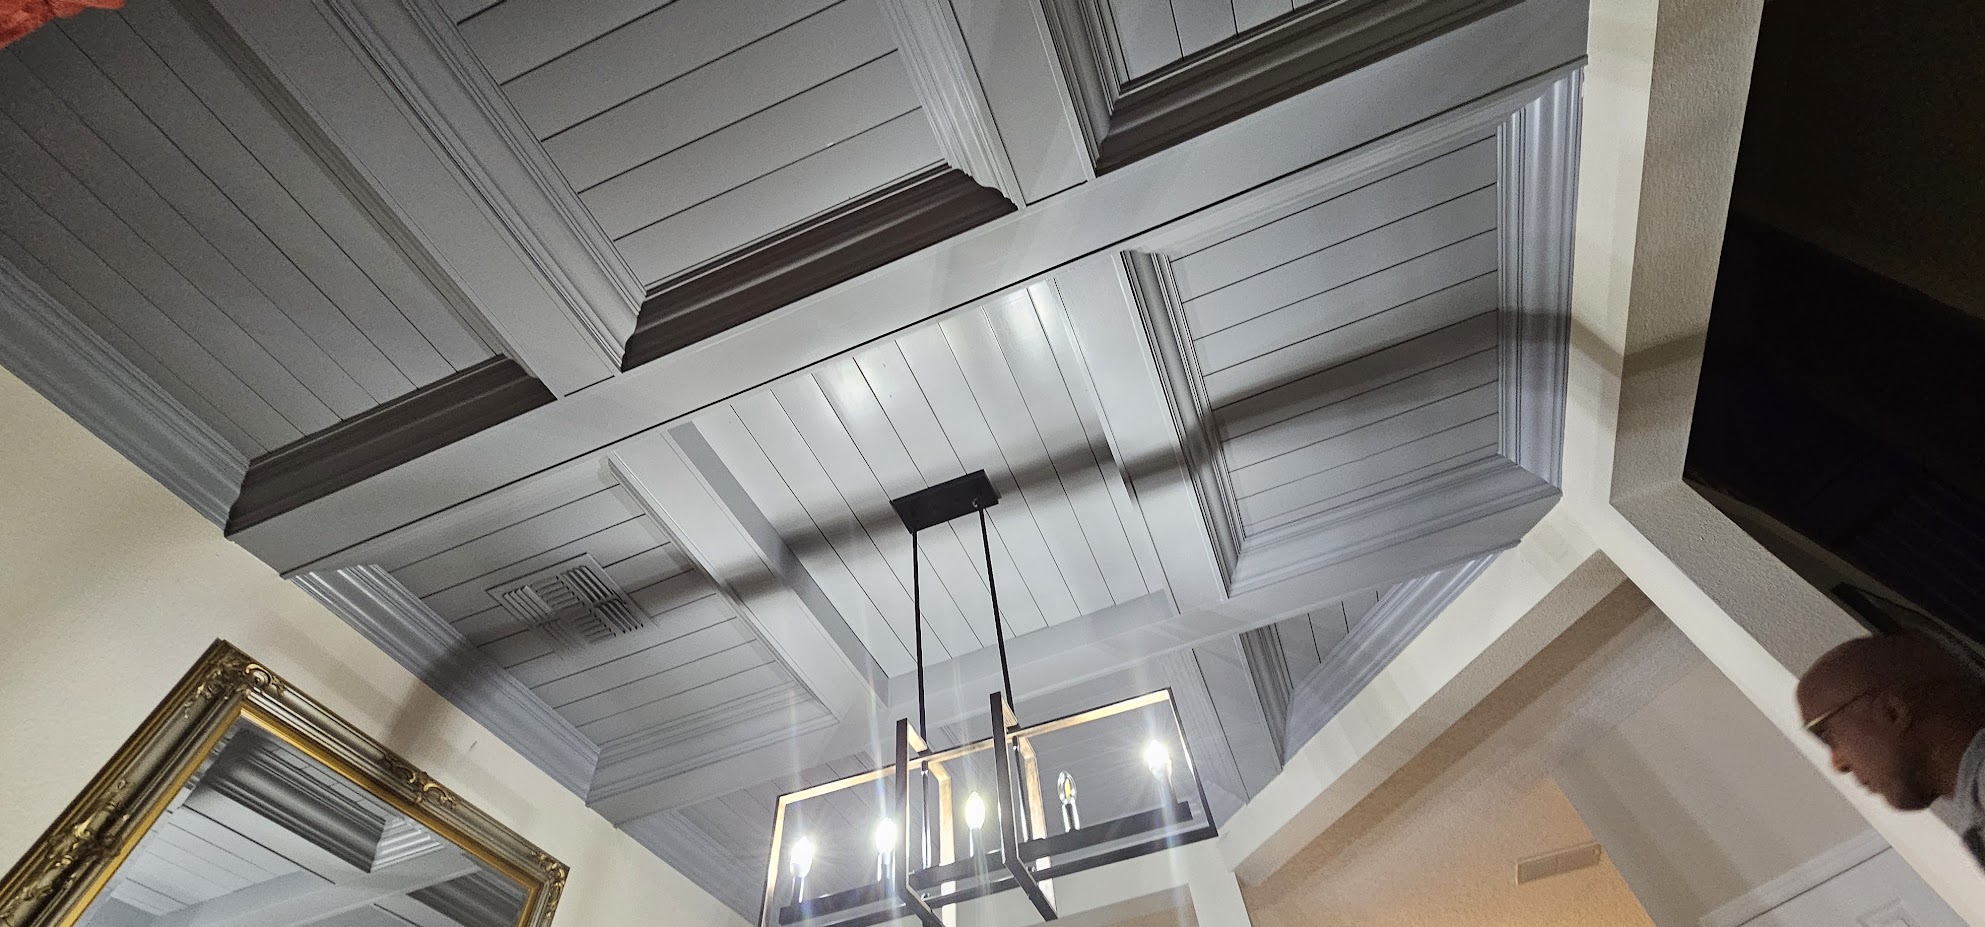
[{"xmin": 226, "ymin": 357, "xmax": 554, "ymax": 534}]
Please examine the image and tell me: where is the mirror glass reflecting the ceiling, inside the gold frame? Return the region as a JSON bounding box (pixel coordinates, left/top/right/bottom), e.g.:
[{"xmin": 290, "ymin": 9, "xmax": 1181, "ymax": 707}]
[{"xmin": 79, "ymin": 721, "xmax": 526, "ymax": 927}]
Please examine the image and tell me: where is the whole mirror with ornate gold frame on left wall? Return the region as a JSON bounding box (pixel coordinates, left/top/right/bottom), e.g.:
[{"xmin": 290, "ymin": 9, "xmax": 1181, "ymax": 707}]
[{"xmin": 0, "ymin": 641, "xmax": 566, "ymax": 927}]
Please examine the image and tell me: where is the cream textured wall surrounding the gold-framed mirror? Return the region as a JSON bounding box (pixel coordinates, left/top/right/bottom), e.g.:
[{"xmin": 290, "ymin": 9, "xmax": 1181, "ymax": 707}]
[{"xmin": 0, "ymin": 371, "xmax": 742, "ymax": 927}]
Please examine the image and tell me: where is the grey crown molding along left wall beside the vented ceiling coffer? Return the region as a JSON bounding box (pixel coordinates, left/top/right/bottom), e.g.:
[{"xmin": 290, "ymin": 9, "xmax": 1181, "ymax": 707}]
[{"xmin": 292, "ymin": 566, "xmax": 599, "ymax": 798}]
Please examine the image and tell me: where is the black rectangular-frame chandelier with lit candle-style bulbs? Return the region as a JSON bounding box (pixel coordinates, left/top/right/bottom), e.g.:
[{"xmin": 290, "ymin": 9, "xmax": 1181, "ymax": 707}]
[{"xmin": 758, "ymin": 470, "xmax": 1215, "ymax": 927}]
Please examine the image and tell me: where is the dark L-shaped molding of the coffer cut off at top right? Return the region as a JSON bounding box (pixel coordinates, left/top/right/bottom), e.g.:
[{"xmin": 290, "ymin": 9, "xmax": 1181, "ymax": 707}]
[{"xmin": 1054, "ymin": 0, "xmax": 1517, "ymax": 173}]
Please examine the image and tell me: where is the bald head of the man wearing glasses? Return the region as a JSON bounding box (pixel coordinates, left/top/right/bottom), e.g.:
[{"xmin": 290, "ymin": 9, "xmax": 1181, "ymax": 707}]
[{"xmin": 1798, "ymin": 635, "xmax": 1985, "ymax": 810}]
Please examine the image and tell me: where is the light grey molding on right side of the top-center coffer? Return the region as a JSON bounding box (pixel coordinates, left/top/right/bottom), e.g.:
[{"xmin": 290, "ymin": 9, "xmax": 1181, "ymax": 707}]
[{"xmin": 881, "ymin": 0, "xmax": 1026, "ymax": 204}]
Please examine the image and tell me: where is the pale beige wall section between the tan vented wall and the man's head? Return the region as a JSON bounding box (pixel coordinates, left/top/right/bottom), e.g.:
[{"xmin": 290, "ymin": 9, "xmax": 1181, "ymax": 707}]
[{"xmin": 1558, "ymin": 663, "xmax": 1868, "ymax": 927}]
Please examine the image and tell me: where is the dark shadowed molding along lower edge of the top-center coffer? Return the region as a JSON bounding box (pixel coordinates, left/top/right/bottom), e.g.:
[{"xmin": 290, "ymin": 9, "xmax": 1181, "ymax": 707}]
[{"xmin": 621, "ymin": 165, "xmax": 1014, "ymax": 369}]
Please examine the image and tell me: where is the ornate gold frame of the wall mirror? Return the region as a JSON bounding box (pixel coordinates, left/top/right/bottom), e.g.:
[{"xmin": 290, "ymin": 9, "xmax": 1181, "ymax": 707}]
[{"xmin": 0, "ymin": 641, "xmax": 568, "ymax": 927}]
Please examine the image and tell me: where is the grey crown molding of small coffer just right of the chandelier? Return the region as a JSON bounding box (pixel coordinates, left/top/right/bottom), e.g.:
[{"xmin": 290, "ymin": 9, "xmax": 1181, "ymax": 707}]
[{"xmin": 1282, "ymin": 554, "xmax": 1495, "ymax": 756}]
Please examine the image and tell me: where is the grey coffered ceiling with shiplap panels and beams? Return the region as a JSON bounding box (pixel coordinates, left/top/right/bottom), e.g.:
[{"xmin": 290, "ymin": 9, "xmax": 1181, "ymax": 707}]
[{"xmin": 0, "ymin": 0, "xmax": 1586, "ymax": 915}]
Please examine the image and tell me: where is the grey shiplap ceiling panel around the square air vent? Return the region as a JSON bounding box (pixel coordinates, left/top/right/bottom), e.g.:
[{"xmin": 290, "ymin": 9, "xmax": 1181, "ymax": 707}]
[{"xmin": 391, "ymin": 472, "xmax": 817, "ymax": 744}]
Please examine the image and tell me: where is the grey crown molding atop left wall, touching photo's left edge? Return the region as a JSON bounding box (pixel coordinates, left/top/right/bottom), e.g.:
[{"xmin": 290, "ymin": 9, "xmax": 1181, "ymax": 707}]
[{"xmin": 0, "ymin": 258, "xmax": 248, "ymax": 524}]
